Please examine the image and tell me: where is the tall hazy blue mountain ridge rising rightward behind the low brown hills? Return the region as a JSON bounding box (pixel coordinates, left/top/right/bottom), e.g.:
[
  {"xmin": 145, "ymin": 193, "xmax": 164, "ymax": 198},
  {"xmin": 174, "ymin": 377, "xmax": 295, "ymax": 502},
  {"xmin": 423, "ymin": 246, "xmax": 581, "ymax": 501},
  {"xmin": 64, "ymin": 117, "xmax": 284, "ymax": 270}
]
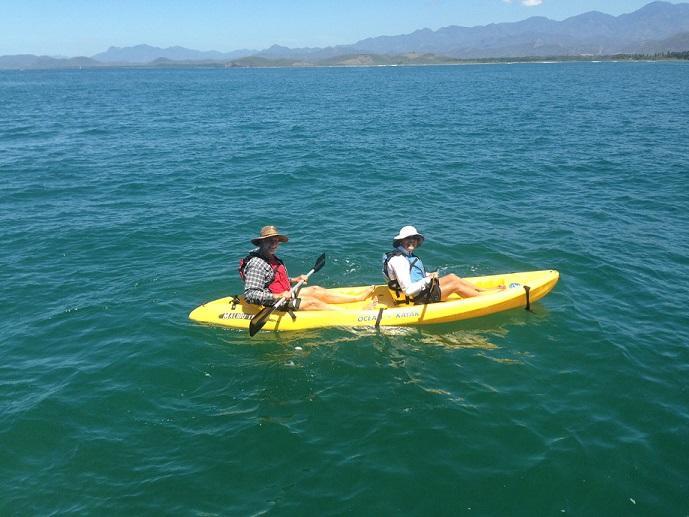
[{"xmin": 258, "ymin": 2, "xmax": 689, "ymax": 60}]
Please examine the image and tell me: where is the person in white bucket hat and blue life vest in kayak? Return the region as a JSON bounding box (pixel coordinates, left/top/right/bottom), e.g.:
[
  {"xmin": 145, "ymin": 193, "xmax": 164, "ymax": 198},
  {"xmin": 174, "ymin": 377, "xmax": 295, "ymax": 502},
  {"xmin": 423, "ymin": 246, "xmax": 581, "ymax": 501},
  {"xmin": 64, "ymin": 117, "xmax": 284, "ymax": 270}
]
[{"xmin": 383, "ymin": 226, "xmax": 490, "ymax": 304}]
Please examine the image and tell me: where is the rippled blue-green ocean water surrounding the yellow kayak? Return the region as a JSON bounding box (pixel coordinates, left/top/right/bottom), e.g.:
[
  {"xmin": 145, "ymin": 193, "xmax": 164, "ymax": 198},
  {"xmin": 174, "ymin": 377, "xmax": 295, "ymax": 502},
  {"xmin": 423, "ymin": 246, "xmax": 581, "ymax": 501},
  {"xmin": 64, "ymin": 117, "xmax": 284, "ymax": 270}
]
[{"xmin": 0, "ymin": 62, "xmax": 689, "ymax": 516}]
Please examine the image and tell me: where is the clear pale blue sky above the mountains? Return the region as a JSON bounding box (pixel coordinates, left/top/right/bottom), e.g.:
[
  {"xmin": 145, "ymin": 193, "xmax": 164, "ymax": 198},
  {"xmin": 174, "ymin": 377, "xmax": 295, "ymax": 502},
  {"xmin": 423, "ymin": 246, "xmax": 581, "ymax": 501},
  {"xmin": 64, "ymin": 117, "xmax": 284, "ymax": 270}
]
[{"xmin": 0, "ymin": 0, "xmax": 660, "ymax": 57}]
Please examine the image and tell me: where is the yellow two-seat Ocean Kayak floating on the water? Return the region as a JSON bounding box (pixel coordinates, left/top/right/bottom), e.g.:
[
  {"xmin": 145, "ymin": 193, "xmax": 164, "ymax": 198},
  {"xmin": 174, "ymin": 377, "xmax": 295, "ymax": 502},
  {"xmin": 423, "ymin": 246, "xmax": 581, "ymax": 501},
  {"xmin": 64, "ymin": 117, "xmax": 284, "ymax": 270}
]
[{"xmin": 189, "ymin": 269, "xmax": 560, "ymax": 331}]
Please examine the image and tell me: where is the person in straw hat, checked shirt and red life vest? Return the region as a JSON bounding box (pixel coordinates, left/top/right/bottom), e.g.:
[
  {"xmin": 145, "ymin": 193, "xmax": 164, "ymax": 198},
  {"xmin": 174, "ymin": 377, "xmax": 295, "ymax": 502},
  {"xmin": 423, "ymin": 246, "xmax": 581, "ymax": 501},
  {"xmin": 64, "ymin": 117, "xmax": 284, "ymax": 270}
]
[{"xmin": 239, "ymin": 226, "xmax": 376, "ymax": 310}]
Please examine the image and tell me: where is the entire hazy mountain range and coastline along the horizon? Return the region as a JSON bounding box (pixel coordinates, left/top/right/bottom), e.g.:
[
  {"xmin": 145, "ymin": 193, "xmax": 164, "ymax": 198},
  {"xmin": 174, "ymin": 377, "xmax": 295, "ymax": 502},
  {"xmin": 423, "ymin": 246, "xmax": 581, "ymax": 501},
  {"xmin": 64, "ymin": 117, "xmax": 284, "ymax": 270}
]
[{"xmin": 0, "ymin": 2, "xmax": 689, "ymax": 69}]
